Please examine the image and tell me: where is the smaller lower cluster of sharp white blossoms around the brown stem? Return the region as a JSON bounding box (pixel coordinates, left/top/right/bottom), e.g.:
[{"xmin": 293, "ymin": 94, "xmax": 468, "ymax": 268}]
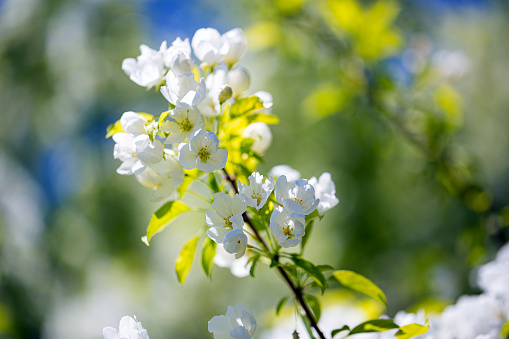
[{"xmin": 205, "ymin": 167, "xmax": 338, "ymax": 259}]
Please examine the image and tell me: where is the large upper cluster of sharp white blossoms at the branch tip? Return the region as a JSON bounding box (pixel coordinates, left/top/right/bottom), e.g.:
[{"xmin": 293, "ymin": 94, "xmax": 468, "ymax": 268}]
[{"xmin": 113, "ymin": 28, "xmax": 272, "ymax": 200}]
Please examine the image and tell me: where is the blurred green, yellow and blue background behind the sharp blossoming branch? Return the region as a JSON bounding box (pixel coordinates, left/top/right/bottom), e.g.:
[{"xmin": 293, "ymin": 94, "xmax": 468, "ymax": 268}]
[{"xmin": 0, "ymin": 0, "xmax": 509, "ymax": 339}]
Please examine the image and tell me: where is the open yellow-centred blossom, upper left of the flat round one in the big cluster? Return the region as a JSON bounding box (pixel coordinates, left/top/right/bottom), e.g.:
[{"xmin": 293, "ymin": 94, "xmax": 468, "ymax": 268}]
[{"xmin": 160, "ymin": 101, "xmax": 202, "ymax": 143}]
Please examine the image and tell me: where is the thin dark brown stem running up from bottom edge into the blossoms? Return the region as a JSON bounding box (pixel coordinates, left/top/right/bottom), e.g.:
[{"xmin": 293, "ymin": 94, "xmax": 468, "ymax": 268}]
[{"xmin": 219, "ymin": 169, "xmax": 325, "ymax": 339}]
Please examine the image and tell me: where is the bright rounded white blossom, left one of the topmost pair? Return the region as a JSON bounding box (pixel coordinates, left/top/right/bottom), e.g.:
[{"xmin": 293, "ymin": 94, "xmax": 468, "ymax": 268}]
[{"xmin": 191, "ymin": 28, "xmax": 228, "ymax": 65}]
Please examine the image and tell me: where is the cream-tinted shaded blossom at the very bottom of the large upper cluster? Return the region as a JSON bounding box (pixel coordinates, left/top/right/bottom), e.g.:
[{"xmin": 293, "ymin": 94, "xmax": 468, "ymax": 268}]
[{"xmin": 136, "ymin": 150, "xmax": 184, "ymax": 201}]
